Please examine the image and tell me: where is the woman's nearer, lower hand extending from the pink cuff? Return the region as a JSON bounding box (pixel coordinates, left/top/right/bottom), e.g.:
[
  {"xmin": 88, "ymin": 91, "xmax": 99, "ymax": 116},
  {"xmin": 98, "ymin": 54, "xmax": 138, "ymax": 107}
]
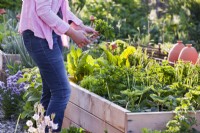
[{"xmin": 65, "ymin": 27, "xmax": 90, "ymax": 47}]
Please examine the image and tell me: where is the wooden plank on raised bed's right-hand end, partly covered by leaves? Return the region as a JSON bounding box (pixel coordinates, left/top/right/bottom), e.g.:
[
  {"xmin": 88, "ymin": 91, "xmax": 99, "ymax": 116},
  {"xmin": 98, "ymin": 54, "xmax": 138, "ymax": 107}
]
[{"xmin": 125, "ymin": 112, "xmax": 200, "ymax": 133}]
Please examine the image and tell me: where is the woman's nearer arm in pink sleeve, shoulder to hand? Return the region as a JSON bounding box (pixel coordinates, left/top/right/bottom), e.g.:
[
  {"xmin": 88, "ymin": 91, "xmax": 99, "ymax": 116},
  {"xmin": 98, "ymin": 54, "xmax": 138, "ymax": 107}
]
[{"xmin": 35, "ymin": 0, "xmax": 90, "ymax": 47}]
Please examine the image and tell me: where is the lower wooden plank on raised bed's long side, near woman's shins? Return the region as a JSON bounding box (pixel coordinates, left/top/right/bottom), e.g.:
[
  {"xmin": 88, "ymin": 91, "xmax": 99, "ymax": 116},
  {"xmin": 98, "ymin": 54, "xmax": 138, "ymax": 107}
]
[{"xmin": 65, "ymin": 102, "xmax": 123, "ymax": 133}]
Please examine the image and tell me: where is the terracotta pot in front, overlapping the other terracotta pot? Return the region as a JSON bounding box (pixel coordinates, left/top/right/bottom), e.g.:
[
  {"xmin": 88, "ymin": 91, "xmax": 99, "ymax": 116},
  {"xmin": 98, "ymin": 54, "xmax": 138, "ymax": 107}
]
[{"xmin": 178, "ymin": 44, "xmax": 198, "ymax": 64}]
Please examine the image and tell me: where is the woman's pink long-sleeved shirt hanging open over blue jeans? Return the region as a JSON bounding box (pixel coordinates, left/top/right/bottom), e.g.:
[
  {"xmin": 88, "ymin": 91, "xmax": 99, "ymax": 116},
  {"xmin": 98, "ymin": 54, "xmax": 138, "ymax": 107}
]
[{"xmin": 19, "ymin": 0, "xmax": 82, "ymax": 49}]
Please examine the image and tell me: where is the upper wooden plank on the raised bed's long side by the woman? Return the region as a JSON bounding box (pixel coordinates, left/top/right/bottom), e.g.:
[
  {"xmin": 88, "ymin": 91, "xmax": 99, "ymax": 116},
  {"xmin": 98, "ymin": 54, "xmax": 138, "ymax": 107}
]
[{"xmin": 70, "ymin": 82, "xmax": 130, "ymax": 132}]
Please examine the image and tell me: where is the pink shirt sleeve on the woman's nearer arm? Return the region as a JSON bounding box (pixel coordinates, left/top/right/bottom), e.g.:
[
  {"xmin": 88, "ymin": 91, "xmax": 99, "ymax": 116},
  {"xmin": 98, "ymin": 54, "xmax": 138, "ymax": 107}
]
[{"xmin": 35, "ymin": 0, "xmax": 70, "ymax": 34}]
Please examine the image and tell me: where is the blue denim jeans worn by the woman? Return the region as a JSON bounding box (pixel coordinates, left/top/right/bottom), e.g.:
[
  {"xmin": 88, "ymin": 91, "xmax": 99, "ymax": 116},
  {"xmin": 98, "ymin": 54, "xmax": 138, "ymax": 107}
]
[{"xmin": 23, "ymin": 30, "xmax": 71, "ymax": 132}]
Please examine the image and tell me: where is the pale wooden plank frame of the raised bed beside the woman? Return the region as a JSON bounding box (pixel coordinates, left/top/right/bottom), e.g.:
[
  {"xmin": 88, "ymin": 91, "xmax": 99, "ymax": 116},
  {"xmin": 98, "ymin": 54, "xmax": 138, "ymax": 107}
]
[{"xmin": 63, "ymin": 82, "xmax": 200, "ymax": 133}]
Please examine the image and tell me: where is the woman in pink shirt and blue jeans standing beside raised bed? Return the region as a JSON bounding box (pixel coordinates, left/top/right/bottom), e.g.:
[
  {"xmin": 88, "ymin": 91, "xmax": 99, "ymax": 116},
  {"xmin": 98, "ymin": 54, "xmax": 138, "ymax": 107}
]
[{"xmin": 19, "ymin": 0, "xmax": 98, "ymax": 132}]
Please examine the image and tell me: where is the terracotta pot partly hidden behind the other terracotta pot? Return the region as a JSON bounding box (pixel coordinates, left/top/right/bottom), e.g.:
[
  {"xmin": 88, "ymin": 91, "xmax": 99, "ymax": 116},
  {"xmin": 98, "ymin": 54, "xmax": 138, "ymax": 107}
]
[{"xmin": 168, "ymin": 41, "xmax": 185, "ymax": 62}]
